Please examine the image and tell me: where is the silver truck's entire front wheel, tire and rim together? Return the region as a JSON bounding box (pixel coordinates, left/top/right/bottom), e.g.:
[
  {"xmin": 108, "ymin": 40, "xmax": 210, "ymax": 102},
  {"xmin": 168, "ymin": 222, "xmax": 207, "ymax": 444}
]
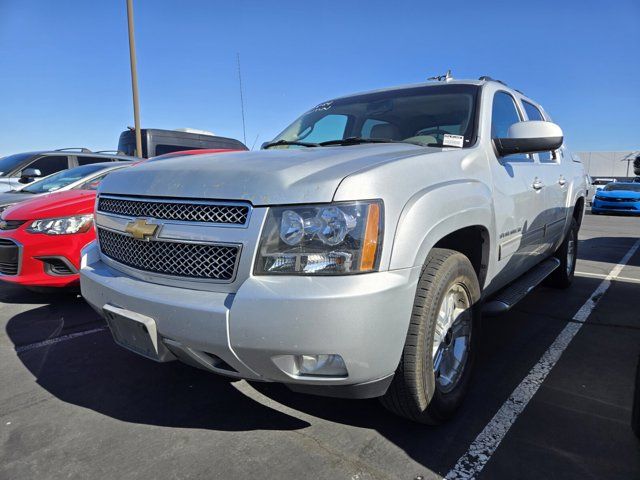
[{"xmin": 381, "ymin": 248, "xmax": 480, "ymax": 424}]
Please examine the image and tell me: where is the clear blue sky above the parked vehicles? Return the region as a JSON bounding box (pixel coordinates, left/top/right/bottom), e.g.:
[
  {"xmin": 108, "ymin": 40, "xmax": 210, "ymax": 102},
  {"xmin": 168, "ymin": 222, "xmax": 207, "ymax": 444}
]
[{"xmin": 0, "ymin": 0, "xmax": 640, "ymax": 155}]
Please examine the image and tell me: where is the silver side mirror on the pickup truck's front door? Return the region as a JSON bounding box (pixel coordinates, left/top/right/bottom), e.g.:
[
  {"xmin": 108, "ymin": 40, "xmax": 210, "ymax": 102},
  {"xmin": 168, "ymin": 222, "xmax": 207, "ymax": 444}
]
[{"xmin": 493, "ymin": 120, "xmax": 564, "ymax": 157}]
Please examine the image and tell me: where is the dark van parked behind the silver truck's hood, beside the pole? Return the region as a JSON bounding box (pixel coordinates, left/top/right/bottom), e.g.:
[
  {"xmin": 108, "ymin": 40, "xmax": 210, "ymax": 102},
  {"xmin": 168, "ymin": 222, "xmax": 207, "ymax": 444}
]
[{"xmin": 118, "ymin": 128, "xmax": 249, "ymax": 158}]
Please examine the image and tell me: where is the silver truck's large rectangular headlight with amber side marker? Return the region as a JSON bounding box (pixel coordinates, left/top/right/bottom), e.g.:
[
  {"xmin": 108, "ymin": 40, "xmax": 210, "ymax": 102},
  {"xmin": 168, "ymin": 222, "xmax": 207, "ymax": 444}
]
[{"xmin": 255, "ymin": 200, "xmax": 383, "ymax": 275}]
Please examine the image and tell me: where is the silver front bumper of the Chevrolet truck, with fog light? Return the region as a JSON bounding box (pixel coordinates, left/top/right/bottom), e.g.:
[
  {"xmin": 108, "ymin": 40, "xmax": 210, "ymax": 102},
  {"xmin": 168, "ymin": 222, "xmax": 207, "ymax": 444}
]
[{"xmin": 81, "ymin": 244, "xmax": 420, "ymax": 397}]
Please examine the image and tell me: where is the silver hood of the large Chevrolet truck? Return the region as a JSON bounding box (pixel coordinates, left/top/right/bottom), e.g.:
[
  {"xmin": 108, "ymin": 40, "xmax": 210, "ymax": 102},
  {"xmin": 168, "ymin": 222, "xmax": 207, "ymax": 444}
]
[{"xmin": 99, "ymin": 143, "xmax": 442, "ymax": 206}]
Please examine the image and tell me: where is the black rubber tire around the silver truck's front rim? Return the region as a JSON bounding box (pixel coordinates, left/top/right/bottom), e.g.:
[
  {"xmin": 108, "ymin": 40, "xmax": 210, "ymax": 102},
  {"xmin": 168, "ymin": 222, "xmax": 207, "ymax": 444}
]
[{"xmin": 381, "ymin": 248, "xmax": 480, "ymax": 425}]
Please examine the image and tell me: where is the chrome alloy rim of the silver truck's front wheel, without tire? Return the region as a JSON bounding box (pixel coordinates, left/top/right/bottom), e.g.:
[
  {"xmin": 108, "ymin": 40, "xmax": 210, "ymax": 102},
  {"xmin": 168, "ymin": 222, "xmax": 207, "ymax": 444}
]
[{"xmin": 432, "ymin": 283, "xmax": 473, "ymax": 393}]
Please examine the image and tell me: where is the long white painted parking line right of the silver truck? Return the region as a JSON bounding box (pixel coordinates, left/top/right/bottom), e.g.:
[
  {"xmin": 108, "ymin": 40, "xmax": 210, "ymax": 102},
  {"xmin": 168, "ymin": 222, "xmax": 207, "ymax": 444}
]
[{"xmin": 445, "ymin": 239, "xmax": 640, "ymax": 480}]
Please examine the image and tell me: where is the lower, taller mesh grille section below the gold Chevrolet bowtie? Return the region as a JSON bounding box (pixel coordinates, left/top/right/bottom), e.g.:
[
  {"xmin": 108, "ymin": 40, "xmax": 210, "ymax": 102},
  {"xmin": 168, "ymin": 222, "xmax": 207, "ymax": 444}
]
[{"xmin": 98, "ymin": 228, "xmax": 238, "ymax": 281}]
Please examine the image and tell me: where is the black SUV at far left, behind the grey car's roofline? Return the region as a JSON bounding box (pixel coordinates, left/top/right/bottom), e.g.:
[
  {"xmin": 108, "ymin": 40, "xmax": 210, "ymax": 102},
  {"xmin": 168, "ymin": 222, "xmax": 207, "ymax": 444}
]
[{"xmin": 0, "ymin": 148, "xmax": 135, "ymax": 192}]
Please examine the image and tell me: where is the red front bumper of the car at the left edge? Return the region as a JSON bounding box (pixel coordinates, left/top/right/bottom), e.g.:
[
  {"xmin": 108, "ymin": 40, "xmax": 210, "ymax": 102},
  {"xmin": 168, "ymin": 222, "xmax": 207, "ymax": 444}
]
[{"xmin": 0, "ymin": 224, "xmax": 95, "ymax": 288}]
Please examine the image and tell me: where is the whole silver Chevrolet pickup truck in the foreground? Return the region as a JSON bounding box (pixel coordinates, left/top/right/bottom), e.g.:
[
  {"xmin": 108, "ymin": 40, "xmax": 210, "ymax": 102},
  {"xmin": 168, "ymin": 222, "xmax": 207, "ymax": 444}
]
[{"xmin": 81, "ymin": 77, "xmax": 586, "ymax": 423}]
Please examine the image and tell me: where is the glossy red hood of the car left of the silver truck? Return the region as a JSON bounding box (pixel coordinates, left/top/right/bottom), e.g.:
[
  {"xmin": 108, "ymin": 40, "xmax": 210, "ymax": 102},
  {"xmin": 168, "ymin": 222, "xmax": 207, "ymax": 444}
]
[{"xmin": 2, "ymin": 190, "xmax": 96, "ymax": 220}]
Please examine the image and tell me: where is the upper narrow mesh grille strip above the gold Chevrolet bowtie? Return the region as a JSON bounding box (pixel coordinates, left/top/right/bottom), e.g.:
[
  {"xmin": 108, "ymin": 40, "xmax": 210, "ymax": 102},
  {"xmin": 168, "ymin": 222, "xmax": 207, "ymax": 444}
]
[{"xmin": 98, "ymin": 197, "xmax": 249, "ymax": 226}]
